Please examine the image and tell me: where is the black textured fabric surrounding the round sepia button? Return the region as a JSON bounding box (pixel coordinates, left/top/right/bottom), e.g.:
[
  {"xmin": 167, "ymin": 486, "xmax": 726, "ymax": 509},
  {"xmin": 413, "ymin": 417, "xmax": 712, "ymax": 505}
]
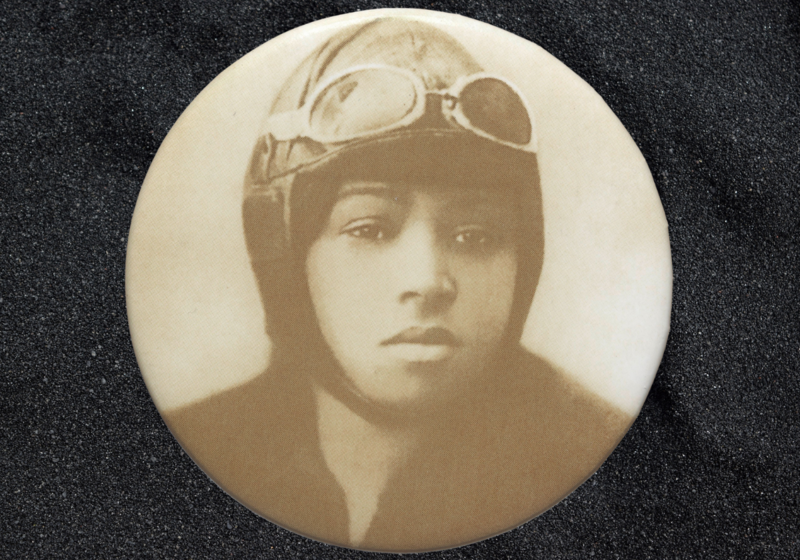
[{"xmin": 0, "ymin": 0, "xmax": 800, "ymax": 559}]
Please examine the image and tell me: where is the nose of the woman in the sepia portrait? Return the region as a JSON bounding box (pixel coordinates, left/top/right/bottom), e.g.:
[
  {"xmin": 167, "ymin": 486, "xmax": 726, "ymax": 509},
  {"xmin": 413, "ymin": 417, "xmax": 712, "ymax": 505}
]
[{"xmin": 396, "ymin": 221, "xmax": 458, "ymax": 313}]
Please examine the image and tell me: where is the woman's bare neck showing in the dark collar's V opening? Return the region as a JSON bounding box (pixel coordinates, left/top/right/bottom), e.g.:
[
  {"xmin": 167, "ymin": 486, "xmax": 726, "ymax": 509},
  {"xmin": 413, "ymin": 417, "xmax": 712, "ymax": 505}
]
[{"xmin": 314, "ymin": 385, "xmax": 417, "ymax": 546}]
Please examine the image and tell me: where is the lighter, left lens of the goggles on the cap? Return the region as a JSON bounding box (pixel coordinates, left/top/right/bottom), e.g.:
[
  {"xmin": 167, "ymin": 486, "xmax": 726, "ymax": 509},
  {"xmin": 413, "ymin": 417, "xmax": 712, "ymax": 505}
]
[{"xmin": 309, "ymin": 69, "xmax": 419, "ymax": 139}]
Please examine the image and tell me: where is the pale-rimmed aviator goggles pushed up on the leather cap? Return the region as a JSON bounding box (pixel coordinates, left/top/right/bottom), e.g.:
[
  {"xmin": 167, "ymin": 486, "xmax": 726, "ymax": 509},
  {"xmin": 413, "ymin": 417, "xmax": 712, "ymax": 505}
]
[{"xmin": 267, "ymin": 64, "xmax": 536, "ymax": 152}]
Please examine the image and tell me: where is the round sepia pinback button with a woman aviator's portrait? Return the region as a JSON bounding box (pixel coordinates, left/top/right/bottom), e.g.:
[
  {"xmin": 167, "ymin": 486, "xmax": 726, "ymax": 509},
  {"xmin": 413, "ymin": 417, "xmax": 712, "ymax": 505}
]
[{"xmin": 126, "ymin": 10, "xmax": 672, "ymax": 552}]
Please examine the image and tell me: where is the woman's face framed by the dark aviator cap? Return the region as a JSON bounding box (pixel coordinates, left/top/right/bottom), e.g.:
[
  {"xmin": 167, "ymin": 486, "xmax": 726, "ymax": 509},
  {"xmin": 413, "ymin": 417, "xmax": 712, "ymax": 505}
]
[{"xmin": 306, "ymin": 181, "xmax": 519, "ymax": 409}]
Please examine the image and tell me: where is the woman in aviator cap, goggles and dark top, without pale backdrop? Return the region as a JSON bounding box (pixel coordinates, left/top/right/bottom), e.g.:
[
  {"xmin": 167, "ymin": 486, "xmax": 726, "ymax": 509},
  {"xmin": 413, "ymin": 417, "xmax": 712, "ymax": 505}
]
[{"xmin": 165, "ymin": 17, "xmax": 632, "ymax": 552}]
